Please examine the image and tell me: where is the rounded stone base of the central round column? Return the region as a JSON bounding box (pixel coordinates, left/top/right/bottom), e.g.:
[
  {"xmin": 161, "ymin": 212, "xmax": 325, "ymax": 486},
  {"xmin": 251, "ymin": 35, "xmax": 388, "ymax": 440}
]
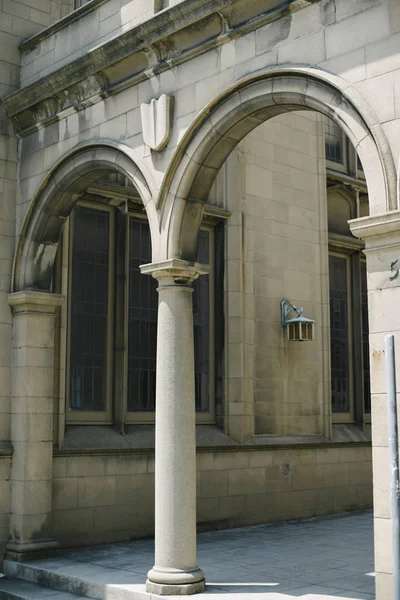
[{"xmin": 146, "ymin": 567, "xmax": 206, "ymax": 596}]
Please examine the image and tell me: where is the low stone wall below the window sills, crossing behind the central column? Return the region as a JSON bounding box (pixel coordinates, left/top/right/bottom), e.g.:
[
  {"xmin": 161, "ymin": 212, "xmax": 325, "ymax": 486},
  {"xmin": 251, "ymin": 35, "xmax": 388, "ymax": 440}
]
[{"xmin": 53, "ymin": 444, "xmax": 372, "ymax": 547}]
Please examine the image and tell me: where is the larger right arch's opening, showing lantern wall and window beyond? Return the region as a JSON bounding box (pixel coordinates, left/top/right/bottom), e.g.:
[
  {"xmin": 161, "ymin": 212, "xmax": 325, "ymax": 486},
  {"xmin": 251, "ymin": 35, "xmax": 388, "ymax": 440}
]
[{"xmin": 187, "ymin": 111, "xmax": 370, "ymax": 443}]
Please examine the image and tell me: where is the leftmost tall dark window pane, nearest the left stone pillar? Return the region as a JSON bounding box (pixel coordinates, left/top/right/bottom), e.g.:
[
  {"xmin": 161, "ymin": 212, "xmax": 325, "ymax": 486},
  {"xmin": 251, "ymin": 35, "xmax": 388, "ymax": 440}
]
[{"xmin": 70, "ymin": 206, "xmax": 110, "ymax": 411}]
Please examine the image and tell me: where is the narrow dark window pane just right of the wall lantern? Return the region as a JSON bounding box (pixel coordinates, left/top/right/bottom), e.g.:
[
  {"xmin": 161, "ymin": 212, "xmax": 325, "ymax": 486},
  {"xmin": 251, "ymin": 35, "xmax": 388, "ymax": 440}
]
[{"xmin": 329, "ymin": 256, "xmax": 350, "ymax": 413}]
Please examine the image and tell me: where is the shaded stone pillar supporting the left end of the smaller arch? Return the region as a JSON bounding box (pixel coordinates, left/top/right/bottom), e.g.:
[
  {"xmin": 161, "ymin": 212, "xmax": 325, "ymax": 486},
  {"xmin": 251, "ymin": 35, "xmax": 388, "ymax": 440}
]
[{"xmin": 6, "ymin": 291, "xmax": 63, "ymax": 560}]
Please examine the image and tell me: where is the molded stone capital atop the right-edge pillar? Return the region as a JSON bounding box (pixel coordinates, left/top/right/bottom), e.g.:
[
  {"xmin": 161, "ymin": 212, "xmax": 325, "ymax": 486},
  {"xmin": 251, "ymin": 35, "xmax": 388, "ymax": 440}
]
[{"xmin": 348, "ymin": 210, "xmax": 400, "ymax": 250}]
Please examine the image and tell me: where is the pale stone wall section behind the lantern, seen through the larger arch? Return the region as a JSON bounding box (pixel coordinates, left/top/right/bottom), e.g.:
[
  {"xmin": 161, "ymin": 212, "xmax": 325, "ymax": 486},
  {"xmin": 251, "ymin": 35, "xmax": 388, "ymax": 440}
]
[{"xmin": 226, "ymin": 112, "xmax": 330, "ymax": 435}]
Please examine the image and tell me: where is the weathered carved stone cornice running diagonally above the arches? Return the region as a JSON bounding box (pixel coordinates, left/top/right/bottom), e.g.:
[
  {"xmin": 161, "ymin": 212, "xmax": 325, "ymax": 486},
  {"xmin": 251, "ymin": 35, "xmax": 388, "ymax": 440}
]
[{"xmin": 1, "ymin": 0, "xmax": 312, "ymax": 136}]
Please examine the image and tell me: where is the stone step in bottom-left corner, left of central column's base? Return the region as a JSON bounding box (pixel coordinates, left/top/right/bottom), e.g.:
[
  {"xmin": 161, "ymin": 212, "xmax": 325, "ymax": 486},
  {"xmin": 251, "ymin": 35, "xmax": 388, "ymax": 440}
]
[{"xmin": 0, "ymin": 558, "xmax": 152, "ymax": 600}]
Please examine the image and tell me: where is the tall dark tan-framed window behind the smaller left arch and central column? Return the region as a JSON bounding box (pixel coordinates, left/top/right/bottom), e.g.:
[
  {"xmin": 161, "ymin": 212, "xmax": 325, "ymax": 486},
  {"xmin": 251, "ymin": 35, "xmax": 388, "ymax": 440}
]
[{"xmin": 57, "ymin": 183, "xmax": 214, "ymax": 424}]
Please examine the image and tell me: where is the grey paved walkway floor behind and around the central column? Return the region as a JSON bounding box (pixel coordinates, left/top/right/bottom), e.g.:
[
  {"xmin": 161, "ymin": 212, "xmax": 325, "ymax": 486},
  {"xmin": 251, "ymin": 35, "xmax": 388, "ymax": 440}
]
[{"xmin": 48, "ymin": 512, "xmax": 375, "ymax": 600}]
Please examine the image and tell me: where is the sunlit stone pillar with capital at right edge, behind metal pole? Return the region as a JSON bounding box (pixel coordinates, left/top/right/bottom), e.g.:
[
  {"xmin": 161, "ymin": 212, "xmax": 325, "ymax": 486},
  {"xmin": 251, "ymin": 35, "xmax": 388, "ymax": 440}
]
[{"xmin": 349, "ymin": 211, "xmax": 400, "ymax": 600}]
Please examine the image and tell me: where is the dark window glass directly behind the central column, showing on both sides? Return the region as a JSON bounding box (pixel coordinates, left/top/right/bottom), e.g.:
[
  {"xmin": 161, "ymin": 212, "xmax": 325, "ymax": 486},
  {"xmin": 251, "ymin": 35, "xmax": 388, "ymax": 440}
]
[{"xmin": 128, "ymin": 217, "xmax": 210, "ymax": 412}]
